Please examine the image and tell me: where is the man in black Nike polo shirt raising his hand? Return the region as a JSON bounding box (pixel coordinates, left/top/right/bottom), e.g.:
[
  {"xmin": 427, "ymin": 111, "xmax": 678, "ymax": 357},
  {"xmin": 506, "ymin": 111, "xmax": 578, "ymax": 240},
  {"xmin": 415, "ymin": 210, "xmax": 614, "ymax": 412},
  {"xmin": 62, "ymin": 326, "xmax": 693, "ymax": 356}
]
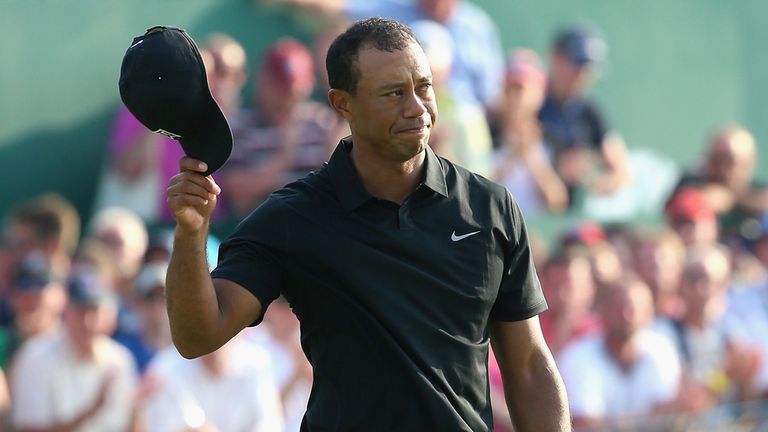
[{"xmin": 167, "ymin": 18, "xmax": 569, "ymax": 431}]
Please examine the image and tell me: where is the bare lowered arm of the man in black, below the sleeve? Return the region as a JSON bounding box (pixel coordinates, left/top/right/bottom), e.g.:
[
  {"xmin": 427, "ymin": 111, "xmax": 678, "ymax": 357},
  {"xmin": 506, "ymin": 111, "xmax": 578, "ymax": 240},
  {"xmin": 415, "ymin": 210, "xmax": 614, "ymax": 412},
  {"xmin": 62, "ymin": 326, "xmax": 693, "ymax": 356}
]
[{"xmin": 491, "ymin": 316, "xmax": 571, "ymax": 432}]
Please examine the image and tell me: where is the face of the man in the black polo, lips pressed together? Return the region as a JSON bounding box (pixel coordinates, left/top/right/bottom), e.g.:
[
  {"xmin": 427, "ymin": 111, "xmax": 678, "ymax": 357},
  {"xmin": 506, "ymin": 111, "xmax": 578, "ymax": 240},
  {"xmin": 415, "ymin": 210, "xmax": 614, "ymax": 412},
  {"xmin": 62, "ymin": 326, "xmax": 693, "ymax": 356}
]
[{"xmin": 343, "ymin": 42, "xmax": 437, "ymax": 162}]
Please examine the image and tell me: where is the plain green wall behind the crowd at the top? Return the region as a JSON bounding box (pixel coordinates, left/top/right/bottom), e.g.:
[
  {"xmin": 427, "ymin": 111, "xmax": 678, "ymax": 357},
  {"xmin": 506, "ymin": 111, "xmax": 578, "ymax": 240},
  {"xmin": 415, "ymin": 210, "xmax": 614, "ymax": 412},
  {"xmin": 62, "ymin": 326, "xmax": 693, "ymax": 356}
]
[{"xmin": 0, "ymin": 0, "xmax": 768, "ymax": 230}]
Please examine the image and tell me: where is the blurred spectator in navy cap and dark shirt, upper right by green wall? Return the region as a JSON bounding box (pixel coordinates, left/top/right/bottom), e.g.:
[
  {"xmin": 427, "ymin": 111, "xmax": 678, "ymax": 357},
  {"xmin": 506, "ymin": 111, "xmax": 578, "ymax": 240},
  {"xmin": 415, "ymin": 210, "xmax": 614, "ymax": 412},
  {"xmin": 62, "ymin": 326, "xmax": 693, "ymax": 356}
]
[{"xmin": 539, "ymin": 26, "xmax": 629, "ymax": 201}]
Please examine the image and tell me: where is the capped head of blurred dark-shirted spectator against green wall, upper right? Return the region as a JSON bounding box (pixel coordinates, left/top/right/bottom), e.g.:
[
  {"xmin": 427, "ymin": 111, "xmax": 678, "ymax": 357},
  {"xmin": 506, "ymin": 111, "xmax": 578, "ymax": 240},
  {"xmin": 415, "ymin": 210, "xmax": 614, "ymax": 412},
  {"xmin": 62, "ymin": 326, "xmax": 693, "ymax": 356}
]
[{"xmin": 549, "ymin": 26, "xmax": 608, "ymax": 100}]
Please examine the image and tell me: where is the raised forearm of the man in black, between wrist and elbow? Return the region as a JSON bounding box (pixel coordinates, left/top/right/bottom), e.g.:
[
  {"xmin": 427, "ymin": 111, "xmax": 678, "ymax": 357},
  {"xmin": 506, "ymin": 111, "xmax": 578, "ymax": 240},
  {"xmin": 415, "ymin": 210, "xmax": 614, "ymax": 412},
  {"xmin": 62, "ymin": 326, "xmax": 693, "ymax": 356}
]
[{"xmin": 166, "ymin": 229, "xmax": 219, "ymax": 358}]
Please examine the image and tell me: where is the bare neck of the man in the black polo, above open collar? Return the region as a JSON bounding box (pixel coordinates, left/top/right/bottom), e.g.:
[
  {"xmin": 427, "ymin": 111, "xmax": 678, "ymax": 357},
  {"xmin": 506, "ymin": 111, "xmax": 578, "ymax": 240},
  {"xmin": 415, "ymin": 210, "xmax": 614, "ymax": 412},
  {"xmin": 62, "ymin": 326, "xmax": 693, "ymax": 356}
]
[{"xmin": 351, "ymin": 143, "xmax": 426, "ymax": 204}]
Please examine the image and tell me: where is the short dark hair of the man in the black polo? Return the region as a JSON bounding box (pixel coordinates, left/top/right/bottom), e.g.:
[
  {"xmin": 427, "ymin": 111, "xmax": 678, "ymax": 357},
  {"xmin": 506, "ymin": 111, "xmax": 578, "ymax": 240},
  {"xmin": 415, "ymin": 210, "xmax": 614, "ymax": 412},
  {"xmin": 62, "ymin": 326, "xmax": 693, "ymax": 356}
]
[{"xmin": 325, "ymin": 17, "xmax": 419, "ymax": 95}]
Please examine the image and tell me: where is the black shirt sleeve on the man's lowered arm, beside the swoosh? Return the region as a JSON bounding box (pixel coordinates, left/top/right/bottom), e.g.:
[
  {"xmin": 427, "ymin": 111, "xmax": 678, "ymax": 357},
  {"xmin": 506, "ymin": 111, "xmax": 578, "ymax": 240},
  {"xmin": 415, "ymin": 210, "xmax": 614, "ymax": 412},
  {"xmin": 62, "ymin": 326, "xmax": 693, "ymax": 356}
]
[{"xmin": 490, "ymin": 192, "xmax": 547, "ymax": 321}]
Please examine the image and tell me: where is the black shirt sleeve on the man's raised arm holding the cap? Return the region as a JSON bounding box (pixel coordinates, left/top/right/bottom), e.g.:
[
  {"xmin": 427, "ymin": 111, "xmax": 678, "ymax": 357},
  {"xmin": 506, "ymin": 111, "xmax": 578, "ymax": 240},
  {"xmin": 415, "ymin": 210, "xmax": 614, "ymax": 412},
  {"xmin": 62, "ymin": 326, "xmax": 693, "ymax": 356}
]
[{"xmin": 211, "ymin": 198, "xmax": 285, "ymax": 325}]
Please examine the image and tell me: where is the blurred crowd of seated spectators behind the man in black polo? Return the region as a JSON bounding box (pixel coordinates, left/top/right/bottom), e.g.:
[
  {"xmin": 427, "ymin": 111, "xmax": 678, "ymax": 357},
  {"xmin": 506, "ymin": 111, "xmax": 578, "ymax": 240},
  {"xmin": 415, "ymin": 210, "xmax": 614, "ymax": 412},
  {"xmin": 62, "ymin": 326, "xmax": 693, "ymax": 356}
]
[{"xmin": 0, "ymin": 0, "xmax": 768, "ymax": 432}]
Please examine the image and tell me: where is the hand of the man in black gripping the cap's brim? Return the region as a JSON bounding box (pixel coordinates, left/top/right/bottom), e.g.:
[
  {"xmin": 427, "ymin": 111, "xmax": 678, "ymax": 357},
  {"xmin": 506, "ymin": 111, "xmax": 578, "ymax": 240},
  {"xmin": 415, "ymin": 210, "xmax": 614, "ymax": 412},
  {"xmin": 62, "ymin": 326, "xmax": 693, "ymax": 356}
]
[{"xmin": 167, "ymin": 157, "xmax": 221, "ymax": 232}]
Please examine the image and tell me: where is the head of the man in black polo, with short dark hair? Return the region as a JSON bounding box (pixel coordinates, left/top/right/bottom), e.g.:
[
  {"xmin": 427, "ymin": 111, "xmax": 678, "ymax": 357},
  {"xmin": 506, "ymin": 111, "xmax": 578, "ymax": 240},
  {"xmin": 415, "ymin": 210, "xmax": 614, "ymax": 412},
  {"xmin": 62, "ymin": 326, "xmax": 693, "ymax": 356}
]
[{"xmin": 326, "ymin": 18, "xmax": 437, "ymax": 161}]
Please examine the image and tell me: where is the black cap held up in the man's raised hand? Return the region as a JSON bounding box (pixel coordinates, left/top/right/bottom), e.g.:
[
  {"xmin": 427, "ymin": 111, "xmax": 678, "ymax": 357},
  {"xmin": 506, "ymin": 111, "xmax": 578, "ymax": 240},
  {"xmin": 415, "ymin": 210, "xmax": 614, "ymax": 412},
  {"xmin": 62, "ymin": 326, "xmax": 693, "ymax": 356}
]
[{"xmin": 120, "ymin": 26, "xmax": 232, "ymax": 175}]
